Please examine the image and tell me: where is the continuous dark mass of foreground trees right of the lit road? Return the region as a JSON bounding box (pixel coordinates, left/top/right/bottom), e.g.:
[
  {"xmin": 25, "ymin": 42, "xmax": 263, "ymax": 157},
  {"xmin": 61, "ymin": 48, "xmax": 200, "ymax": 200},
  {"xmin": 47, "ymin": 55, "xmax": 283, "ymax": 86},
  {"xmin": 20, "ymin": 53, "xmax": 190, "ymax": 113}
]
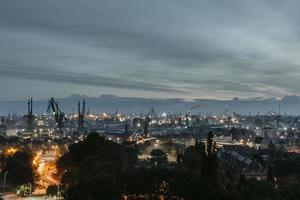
[{"xmin": 57, "ymin": 133, "xmax": 300, "ymax": 200}]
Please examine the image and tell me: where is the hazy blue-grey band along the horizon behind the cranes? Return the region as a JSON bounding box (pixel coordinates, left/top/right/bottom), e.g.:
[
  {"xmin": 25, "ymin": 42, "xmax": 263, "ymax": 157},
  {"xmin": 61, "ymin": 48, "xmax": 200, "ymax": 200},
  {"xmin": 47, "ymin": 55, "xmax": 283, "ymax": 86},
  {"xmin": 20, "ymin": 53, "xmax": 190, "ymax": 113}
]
[{"xmin": 0, "ymin": 94, "xmax": 300, "ymax": 115}]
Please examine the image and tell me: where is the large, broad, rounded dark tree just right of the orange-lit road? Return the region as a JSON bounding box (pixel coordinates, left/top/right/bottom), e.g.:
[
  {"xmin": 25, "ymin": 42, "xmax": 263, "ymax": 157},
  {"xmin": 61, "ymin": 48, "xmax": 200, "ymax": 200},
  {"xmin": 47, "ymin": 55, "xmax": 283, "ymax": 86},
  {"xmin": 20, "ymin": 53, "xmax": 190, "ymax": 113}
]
[{"xmin": 57, "ymin": 133, "xmax": 137, "ymax": 200}]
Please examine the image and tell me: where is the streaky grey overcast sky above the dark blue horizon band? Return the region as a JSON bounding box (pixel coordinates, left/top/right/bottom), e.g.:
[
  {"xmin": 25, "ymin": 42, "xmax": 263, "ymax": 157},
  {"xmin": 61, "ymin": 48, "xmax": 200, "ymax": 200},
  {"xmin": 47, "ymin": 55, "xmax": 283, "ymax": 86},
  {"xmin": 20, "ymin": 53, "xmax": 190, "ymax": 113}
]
[{"xmin": 0, "ymin": 0, "xmax": 300, "ymax": 100}]
